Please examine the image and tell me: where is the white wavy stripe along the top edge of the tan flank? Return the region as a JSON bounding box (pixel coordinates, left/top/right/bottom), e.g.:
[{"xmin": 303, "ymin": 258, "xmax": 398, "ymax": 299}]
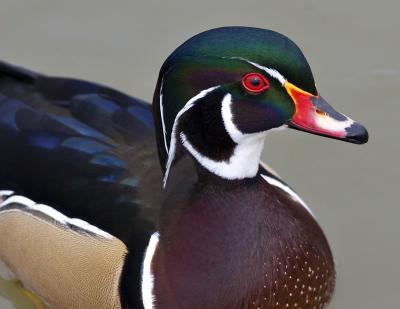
[{"xmin": 0, "ymin": 191, "xmax": 113, "ymax": 238}]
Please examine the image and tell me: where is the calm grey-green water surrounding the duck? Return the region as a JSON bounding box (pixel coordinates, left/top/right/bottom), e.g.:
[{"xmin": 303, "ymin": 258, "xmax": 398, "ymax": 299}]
[{"xmin": 0, "ymin": 0, "xmax": 400, "ymax": 309}]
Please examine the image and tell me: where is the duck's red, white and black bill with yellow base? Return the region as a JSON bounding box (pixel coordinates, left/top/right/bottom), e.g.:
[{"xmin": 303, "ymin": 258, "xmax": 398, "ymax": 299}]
[{"xmin": 284, "ymin": 82, "xmax": 368, "ymax": 144}]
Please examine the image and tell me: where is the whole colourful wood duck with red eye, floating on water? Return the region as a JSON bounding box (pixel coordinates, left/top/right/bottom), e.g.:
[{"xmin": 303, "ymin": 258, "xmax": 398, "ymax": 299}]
[{"xmin": 0, "ymin": 27, "xmax": 368, "ymax": 309}]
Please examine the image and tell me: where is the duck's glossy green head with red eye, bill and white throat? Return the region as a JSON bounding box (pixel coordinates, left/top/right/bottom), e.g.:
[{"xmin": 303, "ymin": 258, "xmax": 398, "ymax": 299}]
[{"xmin": 153, "ymin": 27, "xmax": 368, "ymax": 181}]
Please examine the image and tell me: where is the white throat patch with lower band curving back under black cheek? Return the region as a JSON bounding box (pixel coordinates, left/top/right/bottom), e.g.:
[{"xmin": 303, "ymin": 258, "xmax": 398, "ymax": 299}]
[{"xmin": 179, "ymin": 132, "xmax": 265, "ymax": 179}]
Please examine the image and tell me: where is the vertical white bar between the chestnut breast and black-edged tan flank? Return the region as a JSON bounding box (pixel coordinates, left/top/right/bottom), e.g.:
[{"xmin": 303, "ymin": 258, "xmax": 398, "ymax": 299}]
[{"xmin": 142, "ymin": 232, "xmax": 160, "ymax": 309}]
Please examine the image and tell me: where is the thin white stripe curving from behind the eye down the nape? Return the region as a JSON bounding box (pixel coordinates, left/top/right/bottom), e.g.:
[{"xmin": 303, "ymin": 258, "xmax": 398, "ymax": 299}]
[{"xmin": 164, "ymin": 86, "xmax": 220, "ymax": 187}]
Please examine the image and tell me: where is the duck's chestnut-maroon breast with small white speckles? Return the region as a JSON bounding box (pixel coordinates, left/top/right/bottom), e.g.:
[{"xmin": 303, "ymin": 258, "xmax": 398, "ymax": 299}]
[{"xmin": 152, "ymin": 176, "xmax": 335, "ymax": 309}]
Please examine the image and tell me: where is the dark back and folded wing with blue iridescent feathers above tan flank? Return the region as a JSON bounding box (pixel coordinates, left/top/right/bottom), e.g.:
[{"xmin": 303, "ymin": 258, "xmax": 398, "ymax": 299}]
[{"xmin": 0, "ymin": 63, "xmax": 161, "ymax": 242}]
